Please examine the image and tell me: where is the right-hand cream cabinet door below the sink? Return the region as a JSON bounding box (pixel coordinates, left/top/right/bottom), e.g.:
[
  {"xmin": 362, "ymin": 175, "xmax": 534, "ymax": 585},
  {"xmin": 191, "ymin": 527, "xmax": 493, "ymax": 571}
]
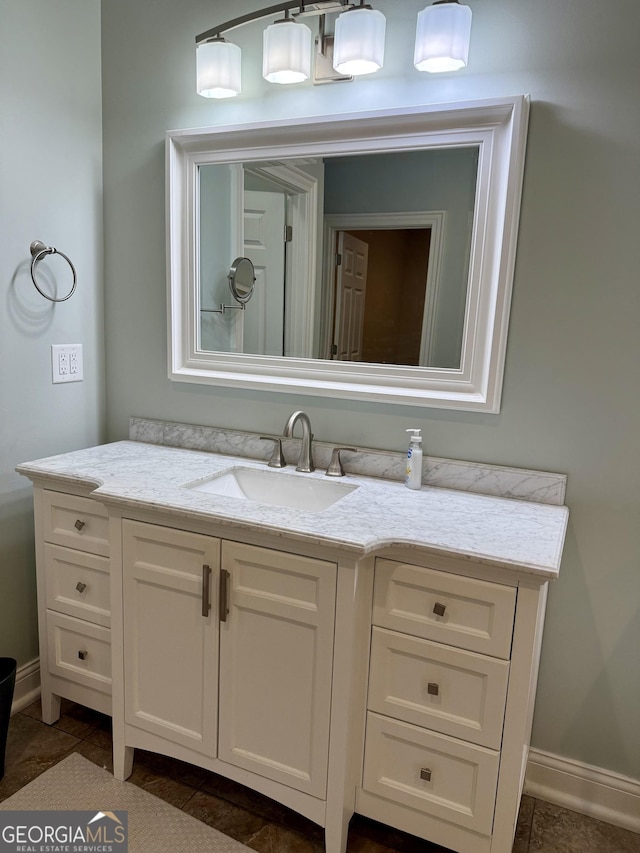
[{"xmin": 218, "ymin": 542, "xmax": 336, "ymax": 798}]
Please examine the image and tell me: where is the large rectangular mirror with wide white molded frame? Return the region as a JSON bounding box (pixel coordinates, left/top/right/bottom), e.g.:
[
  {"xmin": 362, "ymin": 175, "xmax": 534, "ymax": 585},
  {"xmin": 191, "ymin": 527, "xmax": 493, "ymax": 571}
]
[{"xmin": 167, "ymin": 96, "xmax": 528, "ymax": 412}]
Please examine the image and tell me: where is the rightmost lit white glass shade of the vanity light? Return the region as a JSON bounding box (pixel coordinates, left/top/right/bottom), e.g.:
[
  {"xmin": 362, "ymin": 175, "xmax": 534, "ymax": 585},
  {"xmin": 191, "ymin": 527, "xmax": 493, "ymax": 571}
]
[{"xmin": 413, "ymin": 0, "xmax": 471, "ymax": 72}]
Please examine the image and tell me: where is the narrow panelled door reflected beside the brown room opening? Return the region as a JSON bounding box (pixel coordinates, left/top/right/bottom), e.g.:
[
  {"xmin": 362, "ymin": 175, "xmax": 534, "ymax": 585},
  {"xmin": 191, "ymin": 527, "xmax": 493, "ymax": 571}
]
[{"xmin": 333, "ymin": 231, "xmax": 369, "ymax": 361}]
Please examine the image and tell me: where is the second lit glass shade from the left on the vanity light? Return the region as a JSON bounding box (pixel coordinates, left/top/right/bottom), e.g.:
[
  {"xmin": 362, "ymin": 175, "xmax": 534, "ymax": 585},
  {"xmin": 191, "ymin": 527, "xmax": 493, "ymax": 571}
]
[{"xmin": 262, "ymin": 20, "xmax": 313, "ymax": 83}]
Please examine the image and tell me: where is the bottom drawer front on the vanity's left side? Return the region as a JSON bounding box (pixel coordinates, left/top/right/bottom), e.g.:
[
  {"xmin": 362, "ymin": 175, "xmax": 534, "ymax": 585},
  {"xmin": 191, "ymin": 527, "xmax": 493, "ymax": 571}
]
[{"xmin": 47, "ymin": 610, "xmax": 111, "ymax": 694}]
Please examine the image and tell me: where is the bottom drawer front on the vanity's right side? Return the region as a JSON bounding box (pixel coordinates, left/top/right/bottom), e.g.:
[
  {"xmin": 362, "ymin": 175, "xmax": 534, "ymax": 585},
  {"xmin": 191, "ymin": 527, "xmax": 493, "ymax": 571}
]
[{"xmin": 362, "ymin": 713, "xmax": 499, "ymax": 835}]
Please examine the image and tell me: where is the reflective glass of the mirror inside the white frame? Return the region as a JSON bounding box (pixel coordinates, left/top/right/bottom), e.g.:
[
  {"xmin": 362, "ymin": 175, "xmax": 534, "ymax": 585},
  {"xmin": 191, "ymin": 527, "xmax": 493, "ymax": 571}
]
[{"xmin": 198, "ymin": 145, "xmax": 479, "ymax": 369}]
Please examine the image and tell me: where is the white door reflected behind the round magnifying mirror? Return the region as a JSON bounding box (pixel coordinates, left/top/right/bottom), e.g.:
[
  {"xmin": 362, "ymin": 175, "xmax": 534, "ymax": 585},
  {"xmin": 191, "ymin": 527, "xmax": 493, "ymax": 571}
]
[{"xmin": 242, "ymin": 190, "xmax": 285, "ymax": 355}]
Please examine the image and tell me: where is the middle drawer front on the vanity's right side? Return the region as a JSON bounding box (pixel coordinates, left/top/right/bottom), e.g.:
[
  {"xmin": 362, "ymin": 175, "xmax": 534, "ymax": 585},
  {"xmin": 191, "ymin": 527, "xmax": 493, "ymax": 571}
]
[{"xmin": 369, "ymin": 628, "xmax": 509, "ymax": 749}]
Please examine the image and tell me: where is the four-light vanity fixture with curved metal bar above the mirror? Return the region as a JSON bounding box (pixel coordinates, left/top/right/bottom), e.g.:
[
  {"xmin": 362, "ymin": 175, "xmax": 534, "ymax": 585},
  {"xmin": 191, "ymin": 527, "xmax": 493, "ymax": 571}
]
[{"xmin": 196, "ymin": 0, "xmax": 471, "ymax": 98}]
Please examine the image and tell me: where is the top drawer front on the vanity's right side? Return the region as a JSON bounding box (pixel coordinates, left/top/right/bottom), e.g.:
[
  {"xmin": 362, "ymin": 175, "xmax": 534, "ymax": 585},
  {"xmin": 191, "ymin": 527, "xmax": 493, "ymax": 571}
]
[{"xmin": 373, "ymin": 559, "xmax": 516, "ymax": 660}]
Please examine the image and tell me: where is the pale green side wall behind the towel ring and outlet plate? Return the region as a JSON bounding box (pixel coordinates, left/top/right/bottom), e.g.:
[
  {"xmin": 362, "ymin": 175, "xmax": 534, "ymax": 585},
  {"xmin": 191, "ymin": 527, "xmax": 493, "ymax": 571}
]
[{"xmin": 0, "ymin": 0, "xmax": 104, "ymax": 665}]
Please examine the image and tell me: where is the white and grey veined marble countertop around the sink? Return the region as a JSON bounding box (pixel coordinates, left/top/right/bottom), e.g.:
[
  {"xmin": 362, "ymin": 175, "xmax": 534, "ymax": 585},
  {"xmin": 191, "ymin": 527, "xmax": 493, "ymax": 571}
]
[{"xmin": 16, "ymin": 441, "xmax": 569, "ymax": 578}]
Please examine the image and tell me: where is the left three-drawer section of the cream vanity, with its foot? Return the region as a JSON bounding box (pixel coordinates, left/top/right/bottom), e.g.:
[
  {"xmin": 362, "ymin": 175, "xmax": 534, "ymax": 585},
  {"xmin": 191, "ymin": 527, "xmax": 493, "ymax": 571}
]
[{"xmin": 34, "ymin": 487, "xmax": 111, "ymax": 723}]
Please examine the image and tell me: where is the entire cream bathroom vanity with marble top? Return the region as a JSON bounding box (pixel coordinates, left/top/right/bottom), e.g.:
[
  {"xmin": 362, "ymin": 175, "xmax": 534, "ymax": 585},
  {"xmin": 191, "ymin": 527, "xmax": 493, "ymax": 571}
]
[{"xmin": 18, "ymin": 422, "xmax": 568, "ymax": 853}]
